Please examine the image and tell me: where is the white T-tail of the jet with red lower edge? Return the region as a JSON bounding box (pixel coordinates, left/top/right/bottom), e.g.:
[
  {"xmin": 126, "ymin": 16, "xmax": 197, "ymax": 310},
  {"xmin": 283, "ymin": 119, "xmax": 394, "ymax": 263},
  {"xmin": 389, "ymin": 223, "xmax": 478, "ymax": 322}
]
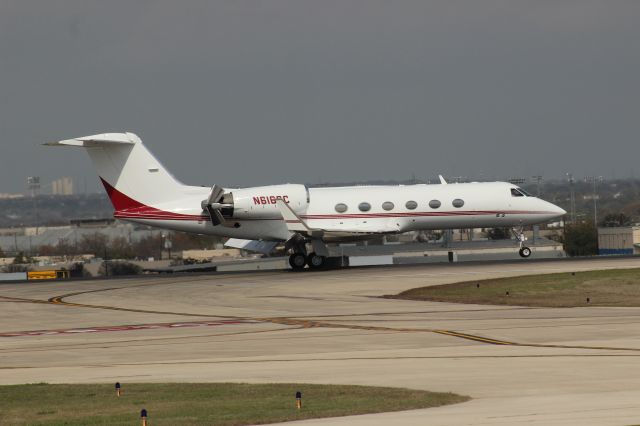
[{"xmin": 45, "ymin": 133, "xmax": 188, "ymax": 210}]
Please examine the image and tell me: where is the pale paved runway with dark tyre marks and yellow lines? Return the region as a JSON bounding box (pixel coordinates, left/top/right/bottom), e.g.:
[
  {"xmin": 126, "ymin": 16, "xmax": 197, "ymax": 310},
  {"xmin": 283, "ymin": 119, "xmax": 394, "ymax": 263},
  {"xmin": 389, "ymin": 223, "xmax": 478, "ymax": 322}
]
[{"xmin": 0, "ymin": 258, "xmax": 640, "ymax": 425}]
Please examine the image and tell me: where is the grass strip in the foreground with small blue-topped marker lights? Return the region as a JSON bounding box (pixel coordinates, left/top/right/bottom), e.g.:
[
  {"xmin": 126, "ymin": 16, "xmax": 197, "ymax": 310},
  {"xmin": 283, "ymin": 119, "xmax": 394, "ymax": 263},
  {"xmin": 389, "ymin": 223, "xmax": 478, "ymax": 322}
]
[{"xmin": 0, "ymin": 383, "xmax": 469, "ymax": 426}]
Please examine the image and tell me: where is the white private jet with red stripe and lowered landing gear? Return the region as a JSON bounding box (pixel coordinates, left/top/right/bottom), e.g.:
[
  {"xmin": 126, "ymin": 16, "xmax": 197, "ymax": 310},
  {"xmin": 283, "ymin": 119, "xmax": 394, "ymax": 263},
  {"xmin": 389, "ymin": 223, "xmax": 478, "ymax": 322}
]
[{"xmin": 46, "ymin": 133, "xmax": 566, "ymax": 269}]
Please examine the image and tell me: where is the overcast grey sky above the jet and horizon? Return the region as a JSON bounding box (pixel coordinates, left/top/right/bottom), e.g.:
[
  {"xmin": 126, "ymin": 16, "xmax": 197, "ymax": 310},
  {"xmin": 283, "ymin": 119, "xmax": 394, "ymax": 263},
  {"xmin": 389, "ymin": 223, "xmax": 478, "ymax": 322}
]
[{"xmin": 0, "ymin": 0, "xmax": 640, "ymax": 192}]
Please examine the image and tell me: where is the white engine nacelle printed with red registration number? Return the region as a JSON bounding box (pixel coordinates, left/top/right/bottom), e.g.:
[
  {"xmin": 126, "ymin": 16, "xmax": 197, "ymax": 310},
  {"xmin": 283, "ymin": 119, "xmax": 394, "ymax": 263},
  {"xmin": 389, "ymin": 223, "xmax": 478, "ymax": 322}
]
[{"xmin": 228, "ymin": 184, "xmax": 309, "ymax": 219}]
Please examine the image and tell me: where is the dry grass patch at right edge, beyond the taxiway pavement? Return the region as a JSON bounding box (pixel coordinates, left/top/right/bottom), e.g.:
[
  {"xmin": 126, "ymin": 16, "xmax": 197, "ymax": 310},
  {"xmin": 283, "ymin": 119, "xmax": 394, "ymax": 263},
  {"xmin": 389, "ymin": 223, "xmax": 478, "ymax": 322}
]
[{"xmin": 385, "ymin": 269, "xmax": 640, "ymax": 307}]
